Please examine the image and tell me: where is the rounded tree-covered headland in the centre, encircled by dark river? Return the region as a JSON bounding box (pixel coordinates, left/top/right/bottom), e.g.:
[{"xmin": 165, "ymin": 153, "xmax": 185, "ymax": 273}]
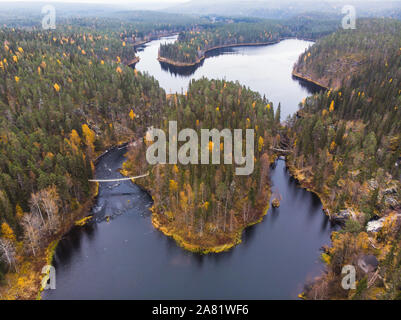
[{"xmin": 124, "ymin": 78, "xmax": 280, "ymax": 253}]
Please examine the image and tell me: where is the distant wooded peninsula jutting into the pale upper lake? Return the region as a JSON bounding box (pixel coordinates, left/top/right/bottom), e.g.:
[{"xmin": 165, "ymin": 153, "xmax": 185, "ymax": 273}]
[{"xmin": 159, "ymin": 16, "xmax": 338, "ymax": 64}]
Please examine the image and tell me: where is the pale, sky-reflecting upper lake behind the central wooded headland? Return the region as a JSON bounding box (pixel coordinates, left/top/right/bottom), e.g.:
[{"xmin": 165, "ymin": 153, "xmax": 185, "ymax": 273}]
[{"xmin": 135, "ymin": 36, "xmax": 320, "ymax": 120}]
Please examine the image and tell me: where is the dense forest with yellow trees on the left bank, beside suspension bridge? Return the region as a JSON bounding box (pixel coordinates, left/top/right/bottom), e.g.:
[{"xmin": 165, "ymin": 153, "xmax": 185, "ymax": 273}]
[{"xmin": 0, "ymin": 23, "xmax": 165, "ymax": 296}]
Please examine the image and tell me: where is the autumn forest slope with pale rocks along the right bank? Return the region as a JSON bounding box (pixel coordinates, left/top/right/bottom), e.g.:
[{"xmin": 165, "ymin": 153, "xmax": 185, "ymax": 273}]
[{"xmin": 288, "ymin": 19, "xmax": 401, "ymax": 299}]
